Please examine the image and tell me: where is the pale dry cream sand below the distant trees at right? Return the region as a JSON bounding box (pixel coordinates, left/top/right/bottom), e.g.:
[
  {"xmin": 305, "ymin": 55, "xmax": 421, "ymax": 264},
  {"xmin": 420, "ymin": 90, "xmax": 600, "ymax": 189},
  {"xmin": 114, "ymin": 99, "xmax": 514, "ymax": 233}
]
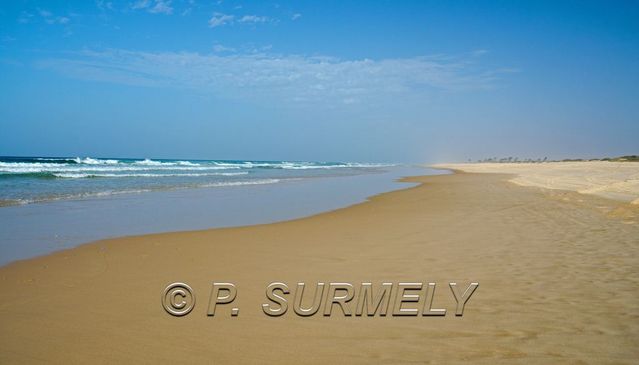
[{"xmin": 435, "ymin": 161, "xmax": 639, "ymax": 204}]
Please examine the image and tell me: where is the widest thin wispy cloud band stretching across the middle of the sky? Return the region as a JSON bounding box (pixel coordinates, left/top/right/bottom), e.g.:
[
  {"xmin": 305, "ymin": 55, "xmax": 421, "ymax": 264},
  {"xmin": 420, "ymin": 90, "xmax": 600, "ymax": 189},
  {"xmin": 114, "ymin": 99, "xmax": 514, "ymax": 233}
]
[{"xmin": 39, "ymin": 46, "xmax": 510, "ymax": 104}]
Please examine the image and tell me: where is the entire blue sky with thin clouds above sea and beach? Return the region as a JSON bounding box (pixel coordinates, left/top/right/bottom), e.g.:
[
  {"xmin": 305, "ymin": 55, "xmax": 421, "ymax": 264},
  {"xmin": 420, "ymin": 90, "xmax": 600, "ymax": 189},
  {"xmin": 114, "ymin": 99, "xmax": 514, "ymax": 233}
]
[{"xmin": 0, "ymin": 0, "xmax": 639, "ymax": 162}]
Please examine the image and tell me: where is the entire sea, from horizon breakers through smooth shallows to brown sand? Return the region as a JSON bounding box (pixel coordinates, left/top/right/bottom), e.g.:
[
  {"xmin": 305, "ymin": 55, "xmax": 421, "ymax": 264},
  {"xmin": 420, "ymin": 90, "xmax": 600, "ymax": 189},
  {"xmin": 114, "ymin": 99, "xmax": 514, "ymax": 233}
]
[{"xmin": 0, "ymin": 157, "xmax": 444, "ymax": 265}]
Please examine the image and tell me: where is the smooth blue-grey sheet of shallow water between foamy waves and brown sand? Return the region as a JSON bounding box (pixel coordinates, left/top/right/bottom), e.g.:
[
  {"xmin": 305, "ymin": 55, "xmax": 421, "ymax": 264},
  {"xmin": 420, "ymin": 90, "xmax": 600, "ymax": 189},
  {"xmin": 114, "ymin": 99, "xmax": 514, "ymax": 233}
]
[{"xmin": 0, "ymin": 167, "xmax": 440, "ymax": 265}]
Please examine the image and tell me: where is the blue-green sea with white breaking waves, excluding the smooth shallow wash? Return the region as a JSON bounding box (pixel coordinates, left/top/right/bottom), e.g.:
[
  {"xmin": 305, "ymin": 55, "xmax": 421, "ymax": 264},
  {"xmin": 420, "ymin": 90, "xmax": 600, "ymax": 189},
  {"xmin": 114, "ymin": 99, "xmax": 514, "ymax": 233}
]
[{"xmin": 0, "ymin": 157, "xmax": 393, "ymax": 206}]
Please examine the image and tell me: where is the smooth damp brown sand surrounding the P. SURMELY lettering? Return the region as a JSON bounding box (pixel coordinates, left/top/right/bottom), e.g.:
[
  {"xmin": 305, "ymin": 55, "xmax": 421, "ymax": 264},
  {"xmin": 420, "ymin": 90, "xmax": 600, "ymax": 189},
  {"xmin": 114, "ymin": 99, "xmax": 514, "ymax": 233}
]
[{"xmin": 0, "ymin": 173, "xmax": 639, "ymax": 364}]
